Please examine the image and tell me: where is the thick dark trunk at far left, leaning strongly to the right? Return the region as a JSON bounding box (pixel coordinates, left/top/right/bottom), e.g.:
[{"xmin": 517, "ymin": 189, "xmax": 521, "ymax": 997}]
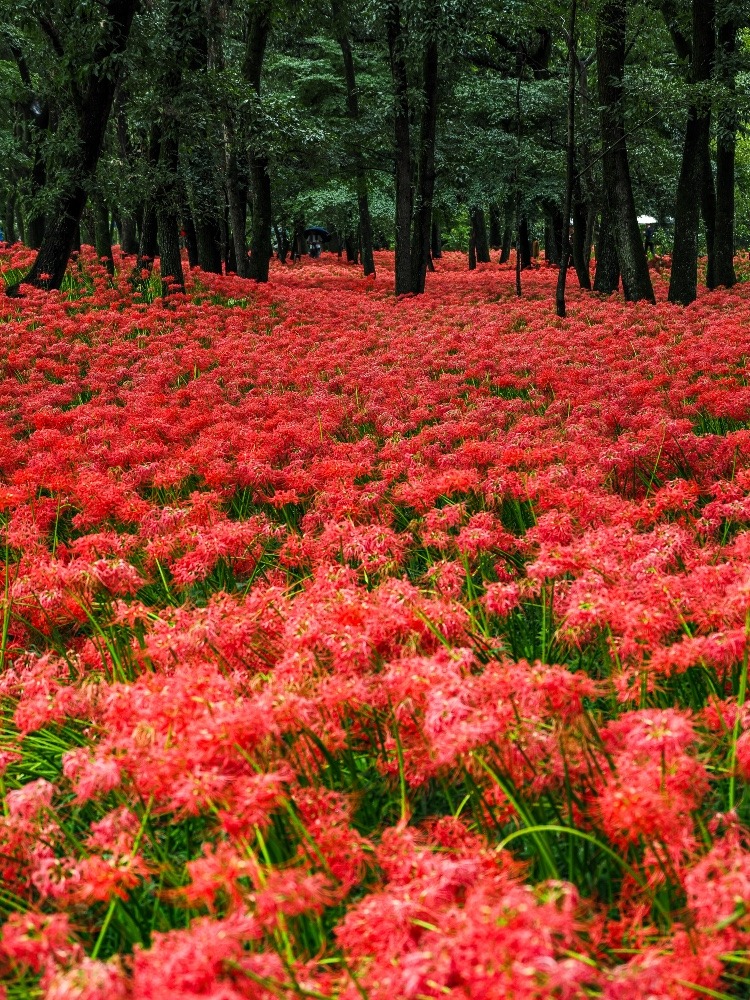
[{"xmin": 18, "ymin": 0, "xmax": 138, "ymax": 288}]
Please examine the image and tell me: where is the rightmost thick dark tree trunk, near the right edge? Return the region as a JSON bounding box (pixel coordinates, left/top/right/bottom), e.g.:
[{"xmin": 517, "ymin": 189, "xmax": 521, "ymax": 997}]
[{"xmin": 714, "ymin": 17, "xmax": 737, "ymax": 288}]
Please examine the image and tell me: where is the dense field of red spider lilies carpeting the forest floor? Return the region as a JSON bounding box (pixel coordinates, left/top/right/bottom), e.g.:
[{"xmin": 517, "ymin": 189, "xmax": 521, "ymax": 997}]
[{"xmin": 0, "ymin": 248, "xmax": 750, "ymax": 1000}]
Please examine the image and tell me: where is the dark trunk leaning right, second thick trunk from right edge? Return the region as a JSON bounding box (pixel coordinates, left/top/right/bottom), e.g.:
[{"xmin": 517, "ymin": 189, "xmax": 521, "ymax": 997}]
[{"xmin": 669, "ymin": 0, "xmax": 716, "ymax": 305}]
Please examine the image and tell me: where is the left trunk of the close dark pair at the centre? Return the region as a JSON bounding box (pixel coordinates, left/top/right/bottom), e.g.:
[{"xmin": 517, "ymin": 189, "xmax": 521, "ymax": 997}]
[{"xmin": 386, "ymin": 0, "xmax": 413, "ymax": 295}]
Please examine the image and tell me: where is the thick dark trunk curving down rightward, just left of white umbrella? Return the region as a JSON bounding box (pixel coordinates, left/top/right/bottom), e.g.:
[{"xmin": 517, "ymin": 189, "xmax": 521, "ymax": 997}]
[{"xmin": 596, "ymin": 0, "xmax": 656, "ymax": 302}]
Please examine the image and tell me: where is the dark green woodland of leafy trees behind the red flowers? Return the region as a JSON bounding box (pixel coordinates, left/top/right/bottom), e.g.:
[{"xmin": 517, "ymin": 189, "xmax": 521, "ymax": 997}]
[{"xmin": 0, "ymin": 0, "xmax": 750, "ymax": 303}]
